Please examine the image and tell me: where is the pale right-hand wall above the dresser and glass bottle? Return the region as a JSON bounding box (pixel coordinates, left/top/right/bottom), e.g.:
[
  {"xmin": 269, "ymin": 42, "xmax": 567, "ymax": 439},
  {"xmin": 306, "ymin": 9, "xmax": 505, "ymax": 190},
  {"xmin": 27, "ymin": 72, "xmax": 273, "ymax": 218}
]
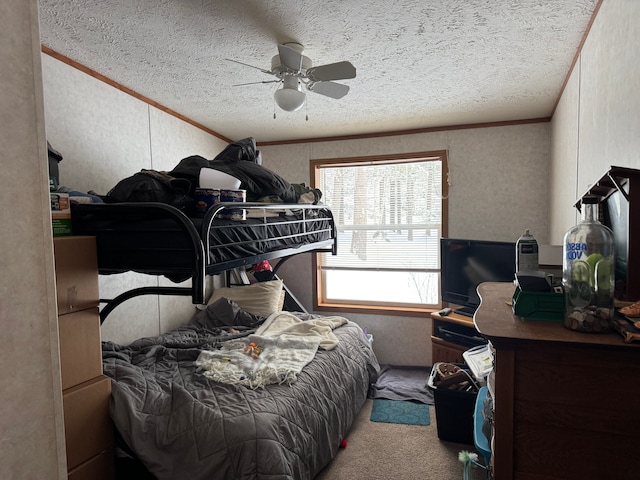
[{"xmin": 550, "ymin": 0, "xmax": 640, "ymax": 244}]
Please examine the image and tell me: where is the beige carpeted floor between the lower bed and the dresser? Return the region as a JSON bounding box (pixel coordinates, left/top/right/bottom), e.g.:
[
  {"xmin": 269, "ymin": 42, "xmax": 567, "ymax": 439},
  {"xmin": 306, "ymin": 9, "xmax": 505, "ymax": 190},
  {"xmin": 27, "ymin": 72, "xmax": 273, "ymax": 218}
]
[{"xmin": 316, "ymin": 365, "xmax": 487, "ymax": 480}]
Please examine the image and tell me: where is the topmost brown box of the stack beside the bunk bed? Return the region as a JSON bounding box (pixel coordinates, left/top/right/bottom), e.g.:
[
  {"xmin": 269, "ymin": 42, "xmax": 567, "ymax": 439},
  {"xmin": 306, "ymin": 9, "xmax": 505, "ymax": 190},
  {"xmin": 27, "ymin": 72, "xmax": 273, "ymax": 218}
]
[{"xmin": 53, "ymin": 236, "xmax": 100, "ymax": 315}]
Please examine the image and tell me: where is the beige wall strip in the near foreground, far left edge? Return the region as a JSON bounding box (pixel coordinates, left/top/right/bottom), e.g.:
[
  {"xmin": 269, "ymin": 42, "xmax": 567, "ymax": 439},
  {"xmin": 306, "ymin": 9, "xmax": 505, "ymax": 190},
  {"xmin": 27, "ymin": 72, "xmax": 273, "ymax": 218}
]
[{"xmin": 0, "ymin": 0, "xmax": 66, "ymax": 479}]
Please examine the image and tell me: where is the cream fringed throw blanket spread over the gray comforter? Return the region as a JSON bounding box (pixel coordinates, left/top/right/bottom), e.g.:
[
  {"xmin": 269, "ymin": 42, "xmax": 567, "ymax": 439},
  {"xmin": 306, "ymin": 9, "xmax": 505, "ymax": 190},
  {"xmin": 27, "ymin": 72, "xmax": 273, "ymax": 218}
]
[{"xmin": 195, "ymin": 312, "xmax": 348, "ymax": 388}]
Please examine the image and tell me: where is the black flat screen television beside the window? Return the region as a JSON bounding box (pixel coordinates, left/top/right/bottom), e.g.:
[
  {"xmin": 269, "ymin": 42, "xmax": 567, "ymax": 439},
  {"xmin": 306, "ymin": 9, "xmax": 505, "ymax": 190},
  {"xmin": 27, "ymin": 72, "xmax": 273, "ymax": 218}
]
[{"xmin": 440, "ymin": 238, "xmax": 516, "ymax": 317}]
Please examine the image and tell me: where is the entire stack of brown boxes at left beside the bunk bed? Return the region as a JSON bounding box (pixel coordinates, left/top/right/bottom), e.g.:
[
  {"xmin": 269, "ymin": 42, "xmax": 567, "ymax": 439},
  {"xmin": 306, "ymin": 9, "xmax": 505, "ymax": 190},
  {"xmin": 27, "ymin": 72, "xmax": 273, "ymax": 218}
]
[{"xmin": 53, "ymin": 237, "xmax": 115, "ymax": 480}]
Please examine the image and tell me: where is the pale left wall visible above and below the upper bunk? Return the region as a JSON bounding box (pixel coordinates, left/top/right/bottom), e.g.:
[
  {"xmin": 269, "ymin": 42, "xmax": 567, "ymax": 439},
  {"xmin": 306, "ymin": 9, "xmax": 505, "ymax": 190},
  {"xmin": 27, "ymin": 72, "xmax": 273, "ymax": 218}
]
[{"xmin": 42, "ymin": 54, "xmax": 226, "ymax": 344}]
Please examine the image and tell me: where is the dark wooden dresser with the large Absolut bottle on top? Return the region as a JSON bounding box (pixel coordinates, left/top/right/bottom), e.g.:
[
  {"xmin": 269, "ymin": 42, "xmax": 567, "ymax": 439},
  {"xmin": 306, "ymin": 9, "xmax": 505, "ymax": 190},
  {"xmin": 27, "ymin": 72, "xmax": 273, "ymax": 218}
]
[{"xmin": 474, "ymin": 283, "xmax": 640, "ymax": 480}]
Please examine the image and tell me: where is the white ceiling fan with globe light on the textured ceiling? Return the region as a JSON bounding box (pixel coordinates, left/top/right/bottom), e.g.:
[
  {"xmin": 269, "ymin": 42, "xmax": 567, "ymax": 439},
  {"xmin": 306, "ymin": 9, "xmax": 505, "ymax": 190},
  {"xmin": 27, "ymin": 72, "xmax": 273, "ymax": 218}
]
[{"xmin": 226, "ymin": 42, "xmax": 356, "ymax": 112}]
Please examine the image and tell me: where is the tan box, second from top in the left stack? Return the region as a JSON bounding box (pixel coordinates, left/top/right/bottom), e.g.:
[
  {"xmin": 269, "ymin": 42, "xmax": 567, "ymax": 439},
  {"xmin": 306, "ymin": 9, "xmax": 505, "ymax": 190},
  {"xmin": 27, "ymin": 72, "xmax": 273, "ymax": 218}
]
[{"xmin": 58, "ymin": 307, "xmax": 102, "ymax": 390}]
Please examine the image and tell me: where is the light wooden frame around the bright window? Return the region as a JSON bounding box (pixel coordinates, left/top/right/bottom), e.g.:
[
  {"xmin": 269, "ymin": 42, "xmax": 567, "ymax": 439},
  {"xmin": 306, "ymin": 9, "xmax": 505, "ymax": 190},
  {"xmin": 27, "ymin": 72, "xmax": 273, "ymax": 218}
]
[{"xmin": 309, "ymin": 150, "xmax": 449, "ymax": 316}]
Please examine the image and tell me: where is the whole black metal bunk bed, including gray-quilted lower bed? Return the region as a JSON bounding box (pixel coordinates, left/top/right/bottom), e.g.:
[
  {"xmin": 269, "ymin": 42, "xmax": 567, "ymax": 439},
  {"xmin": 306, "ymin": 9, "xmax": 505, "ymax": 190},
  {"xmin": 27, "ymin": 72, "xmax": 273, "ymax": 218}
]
[{"xmin": 71, "ymin": 139, "xmax": 379, "ymax": 480}]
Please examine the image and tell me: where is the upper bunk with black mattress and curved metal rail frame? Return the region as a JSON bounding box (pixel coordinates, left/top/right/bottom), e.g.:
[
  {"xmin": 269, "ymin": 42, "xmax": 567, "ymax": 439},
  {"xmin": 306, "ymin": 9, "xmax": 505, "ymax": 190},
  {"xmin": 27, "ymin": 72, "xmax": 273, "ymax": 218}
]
[{"xmin": 72, "ymin": 202, "xmax": 337, "ymax": 322}]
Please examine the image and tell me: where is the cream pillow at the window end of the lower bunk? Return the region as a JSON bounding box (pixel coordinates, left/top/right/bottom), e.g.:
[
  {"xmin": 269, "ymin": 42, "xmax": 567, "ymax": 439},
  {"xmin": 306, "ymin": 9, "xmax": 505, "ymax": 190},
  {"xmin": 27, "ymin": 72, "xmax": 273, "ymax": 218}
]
[{"xmin": 208, "ymin": 280, "xmax": 283, "ymax": 317}]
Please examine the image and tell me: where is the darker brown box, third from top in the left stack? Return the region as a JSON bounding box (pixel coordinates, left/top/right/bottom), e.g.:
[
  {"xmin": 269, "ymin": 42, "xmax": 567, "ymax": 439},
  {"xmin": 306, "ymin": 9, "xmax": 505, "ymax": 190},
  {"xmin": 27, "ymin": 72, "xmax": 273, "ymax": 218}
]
[{"xmin": 62, "ymin": 375, "xmax": 113, "ymax": 470}]
